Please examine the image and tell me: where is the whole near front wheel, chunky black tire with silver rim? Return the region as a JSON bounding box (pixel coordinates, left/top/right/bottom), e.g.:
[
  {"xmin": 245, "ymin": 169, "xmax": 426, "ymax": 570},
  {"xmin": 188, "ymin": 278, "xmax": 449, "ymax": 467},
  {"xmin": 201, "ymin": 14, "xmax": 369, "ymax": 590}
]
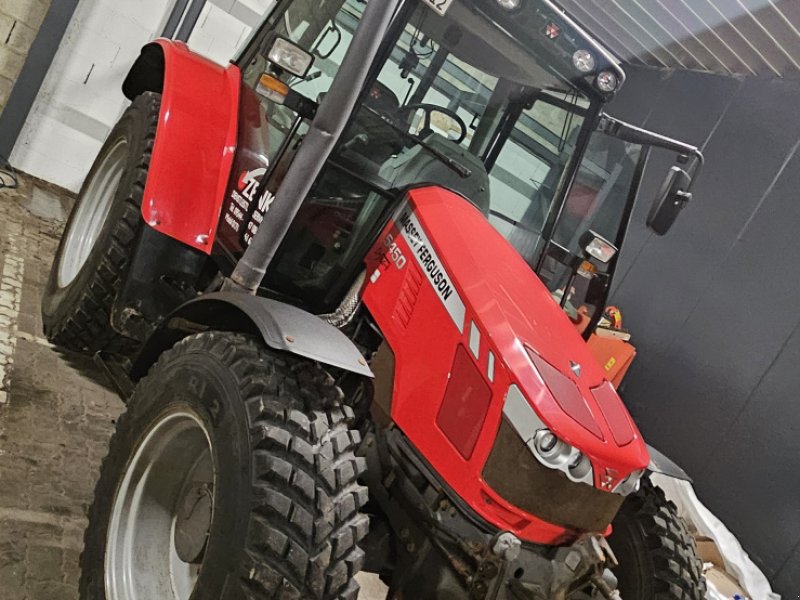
[{"xmin": 80, "ymin": 332, "xmax": 369, "ymax": 600}]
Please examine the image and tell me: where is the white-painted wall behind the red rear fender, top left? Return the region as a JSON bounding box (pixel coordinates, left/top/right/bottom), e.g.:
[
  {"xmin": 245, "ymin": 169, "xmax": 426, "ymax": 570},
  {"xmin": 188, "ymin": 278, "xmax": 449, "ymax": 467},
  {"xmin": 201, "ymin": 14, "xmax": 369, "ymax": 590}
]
[{"xmin": 11, "ymin": 0, "xmax": 274, "ymax": 191}]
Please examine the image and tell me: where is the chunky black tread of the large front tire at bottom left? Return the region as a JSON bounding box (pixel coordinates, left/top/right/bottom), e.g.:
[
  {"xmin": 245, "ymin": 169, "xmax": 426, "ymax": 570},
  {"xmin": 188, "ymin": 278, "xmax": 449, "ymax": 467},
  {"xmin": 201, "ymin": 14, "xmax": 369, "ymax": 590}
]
[{"xmin": 81, "ymin": 332, "xmax": 369, "ymax": 600}]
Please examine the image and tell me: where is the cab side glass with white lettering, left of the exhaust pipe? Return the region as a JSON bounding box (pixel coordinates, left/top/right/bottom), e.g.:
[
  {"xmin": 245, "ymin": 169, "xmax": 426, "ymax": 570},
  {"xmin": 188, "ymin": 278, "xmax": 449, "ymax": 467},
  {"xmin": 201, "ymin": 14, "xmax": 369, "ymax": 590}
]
[{"xmin": 209, "ymin": 0, "xmax": 364, "ymax": 262}]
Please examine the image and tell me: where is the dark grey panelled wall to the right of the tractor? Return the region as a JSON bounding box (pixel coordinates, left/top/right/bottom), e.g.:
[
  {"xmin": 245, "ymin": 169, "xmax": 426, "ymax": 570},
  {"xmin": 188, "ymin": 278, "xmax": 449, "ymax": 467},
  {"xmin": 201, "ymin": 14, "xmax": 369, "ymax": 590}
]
[{"xmin": 610, "ymin": 69, "xmax": 800, "ymax": 597}]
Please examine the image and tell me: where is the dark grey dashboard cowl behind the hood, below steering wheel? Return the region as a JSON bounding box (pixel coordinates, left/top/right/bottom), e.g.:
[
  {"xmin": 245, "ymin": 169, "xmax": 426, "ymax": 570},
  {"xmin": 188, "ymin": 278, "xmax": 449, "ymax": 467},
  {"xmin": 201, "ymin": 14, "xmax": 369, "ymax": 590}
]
[{"xmin": 380, "ymin": 133, "xmax": 489, "ymax": 215}]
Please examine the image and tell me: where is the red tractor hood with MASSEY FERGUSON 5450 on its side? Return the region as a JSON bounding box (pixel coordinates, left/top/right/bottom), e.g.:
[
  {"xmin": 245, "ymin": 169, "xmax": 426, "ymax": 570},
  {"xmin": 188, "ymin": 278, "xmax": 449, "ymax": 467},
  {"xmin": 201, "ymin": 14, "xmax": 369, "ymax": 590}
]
[{"xmin": 364, "ymin": 187, "xmax": 649, "ymax": 544}]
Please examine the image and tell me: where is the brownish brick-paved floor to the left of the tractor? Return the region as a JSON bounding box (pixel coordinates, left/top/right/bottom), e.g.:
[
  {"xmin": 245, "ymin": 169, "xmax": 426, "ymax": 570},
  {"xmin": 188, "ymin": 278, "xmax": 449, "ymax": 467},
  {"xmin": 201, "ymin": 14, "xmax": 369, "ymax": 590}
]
[{"xmin": 0, "ymin": 179, "xmax": 386, "ymax": 600}]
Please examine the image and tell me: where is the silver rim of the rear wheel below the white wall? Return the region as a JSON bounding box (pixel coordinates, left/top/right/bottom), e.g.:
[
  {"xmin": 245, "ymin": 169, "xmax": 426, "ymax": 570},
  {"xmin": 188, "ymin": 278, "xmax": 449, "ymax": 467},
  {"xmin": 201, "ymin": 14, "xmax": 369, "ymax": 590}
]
[{"xmin": 58, "ymin": 138, "xmax": 128, "ymax": 288}]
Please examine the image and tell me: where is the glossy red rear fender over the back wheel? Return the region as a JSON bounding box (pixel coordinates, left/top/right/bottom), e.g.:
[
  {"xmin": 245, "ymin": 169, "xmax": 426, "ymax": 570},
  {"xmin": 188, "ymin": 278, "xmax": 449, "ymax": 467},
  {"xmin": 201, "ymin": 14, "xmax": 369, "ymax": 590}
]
[{"xmin": 142, "ymin": 39, "xmax": 241, "ymax": 254}]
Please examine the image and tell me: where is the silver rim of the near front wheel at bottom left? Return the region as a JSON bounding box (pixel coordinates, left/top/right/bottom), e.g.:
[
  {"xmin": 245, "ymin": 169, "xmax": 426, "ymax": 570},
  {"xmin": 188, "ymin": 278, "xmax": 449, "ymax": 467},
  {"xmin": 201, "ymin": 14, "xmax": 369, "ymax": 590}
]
[{"xmin": 105, "ymin": 407, "xmax": 215, "ymax": 600}]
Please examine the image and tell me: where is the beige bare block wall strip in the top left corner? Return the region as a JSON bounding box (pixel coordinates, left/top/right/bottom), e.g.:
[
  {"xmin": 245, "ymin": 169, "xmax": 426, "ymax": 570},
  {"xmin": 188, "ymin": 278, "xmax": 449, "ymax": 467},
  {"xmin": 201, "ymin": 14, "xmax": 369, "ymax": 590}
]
[{"xmin": 0, "ymin": 0, "xmax": 50, "ymax": 113}]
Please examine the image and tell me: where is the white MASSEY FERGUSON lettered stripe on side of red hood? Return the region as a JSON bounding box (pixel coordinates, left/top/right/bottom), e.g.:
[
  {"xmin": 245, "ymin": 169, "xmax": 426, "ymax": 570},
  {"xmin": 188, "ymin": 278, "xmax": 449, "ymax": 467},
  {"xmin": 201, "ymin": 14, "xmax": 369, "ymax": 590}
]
[{"xmin": 397, "ymin": 211, "xmax": 466, "ymax": 333}]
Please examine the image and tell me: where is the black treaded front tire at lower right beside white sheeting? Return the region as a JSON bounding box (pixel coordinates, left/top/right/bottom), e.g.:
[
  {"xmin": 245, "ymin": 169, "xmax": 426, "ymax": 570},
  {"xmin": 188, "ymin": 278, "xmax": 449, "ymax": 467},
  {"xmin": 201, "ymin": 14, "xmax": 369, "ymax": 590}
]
[{"xmin": 608, "ymin": 478, "xmax": 706, "ymax": 600}]
